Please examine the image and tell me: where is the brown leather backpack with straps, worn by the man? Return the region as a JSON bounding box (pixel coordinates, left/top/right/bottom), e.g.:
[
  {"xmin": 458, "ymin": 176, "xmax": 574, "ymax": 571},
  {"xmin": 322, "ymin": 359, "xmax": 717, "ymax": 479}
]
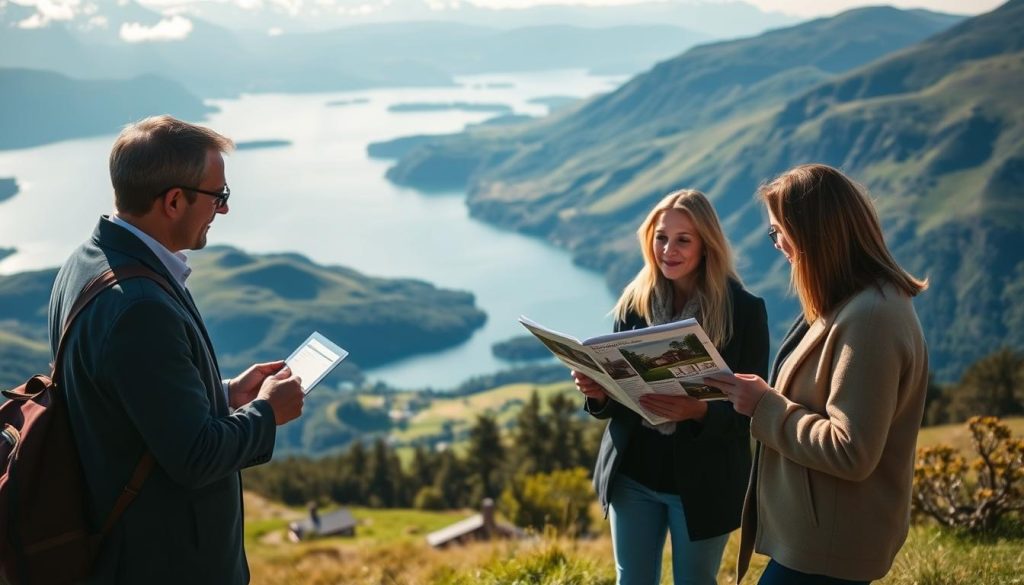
[{"xmin": 0, "ymin": 264, "xmax": 174, "ymax": 585}]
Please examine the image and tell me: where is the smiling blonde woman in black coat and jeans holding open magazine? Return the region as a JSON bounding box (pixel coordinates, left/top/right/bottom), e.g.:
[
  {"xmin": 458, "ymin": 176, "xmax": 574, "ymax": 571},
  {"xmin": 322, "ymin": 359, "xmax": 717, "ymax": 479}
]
[{"xmin": 572, "ymin": 190, "xmax": 768, "ymax": 585}]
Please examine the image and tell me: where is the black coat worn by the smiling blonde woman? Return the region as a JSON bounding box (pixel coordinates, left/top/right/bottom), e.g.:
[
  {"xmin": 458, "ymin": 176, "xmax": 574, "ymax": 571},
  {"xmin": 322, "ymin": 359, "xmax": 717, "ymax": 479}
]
[{"xmin": 586, "ymin": 282, "xmax": 768, "ymax": 540}]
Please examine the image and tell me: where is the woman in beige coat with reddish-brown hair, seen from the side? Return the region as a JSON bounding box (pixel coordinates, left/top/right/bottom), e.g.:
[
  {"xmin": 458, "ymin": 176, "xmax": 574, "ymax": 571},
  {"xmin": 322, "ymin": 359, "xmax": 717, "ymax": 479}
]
[{"xmin": 707, "ymin": 165, "xmax": 928, "ymax": 585}]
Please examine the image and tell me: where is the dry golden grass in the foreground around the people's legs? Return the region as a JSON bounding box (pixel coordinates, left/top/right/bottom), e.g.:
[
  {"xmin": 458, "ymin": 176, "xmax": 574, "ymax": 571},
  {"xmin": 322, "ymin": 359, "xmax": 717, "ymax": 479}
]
[{"xmin": 246, "ymin": 415, "xmax": 1024, "ymax": 585}]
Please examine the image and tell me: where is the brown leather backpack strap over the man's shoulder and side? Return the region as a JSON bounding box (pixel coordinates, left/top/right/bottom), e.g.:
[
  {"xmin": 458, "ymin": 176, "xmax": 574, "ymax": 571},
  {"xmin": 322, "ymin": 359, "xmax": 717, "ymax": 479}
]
[{"xmin": 50, "ymin": 264, "xmax": 177, "ymax": 548}]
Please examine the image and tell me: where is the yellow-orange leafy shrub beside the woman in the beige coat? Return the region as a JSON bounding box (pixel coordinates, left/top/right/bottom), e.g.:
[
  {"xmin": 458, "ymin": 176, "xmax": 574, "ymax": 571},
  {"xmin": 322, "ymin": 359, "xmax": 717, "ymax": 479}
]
[{"xmin": 913, "ymin": 416, "xmax": 1024, "ymax": 533}]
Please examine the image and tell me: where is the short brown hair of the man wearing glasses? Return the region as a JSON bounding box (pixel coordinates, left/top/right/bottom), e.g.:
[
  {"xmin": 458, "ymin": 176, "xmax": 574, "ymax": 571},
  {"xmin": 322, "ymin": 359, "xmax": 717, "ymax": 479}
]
[{"xmin": 110, "ymin": 116, "xmax": 234, "ymax": 215}]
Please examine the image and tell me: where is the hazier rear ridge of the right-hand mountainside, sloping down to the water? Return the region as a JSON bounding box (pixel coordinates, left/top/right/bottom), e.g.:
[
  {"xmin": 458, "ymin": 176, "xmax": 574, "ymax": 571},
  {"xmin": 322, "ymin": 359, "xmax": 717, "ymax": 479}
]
[{"xmin": 388, "ymin": 7, "xmax": 956, "ymax": 192}]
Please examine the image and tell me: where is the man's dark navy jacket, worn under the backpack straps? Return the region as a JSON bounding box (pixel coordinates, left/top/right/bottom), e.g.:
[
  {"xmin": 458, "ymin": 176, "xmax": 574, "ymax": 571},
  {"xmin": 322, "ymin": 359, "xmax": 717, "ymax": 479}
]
[{"xmin": 49, "ymin": 217, "xmax": 275, "ymax": 585}]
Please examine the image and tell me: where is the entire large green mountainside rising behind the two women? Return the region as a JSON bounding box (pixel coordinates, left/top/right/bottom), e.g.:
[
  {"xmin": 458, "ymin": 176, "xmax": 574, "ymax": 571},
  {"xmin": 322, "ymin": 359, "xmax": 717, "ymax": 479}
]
[{"xmin": 389, "ymin": 0, "xmax": 1024, "ymax": 380}]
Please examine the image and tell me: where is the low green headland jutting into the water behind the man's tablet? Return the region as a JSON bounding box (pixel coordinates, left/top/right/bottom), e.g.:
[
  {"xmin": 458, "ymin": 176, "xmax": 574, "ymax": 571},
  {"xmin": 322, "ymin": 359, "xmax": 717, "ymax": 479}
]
[{"xmin": 0, "ymin": 247, "xmax": 486, "ymax": 387}]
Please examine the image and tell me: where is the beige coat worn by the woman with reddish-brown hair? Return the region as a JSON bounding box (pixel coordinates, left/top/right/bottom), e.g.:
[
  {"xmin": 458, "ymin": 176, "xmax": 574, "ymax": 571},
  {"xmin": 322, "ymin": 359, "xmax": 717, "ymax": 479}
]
[{"xmin": 737, "ymin": 286, "xmax": 928, "ymax": 582}]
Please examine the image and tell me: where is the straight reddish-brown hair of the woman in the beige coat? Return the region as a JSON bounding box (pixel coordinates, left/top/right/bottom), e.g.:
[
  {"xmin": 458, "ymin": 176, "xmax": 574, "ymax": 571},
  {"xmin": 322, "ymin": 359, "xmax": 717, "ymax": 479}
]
[{"xmin": 758, "ymin": 164, "xmax": 928, "ymax": 322}]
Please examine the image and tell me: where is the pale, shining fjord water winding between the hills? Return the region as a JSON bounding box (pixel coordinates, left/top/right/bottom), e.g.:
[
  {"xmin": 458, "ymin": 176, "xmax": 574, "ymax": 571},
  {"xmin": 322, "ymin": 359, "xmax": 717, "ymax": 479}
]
[{"xmin": 0, "ymin": 71, "xmax": 617, "ymax": 388}]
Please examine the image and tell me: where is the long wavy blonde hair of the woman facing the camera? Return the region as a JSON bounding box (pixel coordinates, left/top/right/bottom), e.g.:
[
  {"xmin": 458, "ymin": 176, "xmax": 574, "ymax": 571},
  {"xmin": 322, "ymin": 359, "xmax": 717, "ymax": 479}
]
[{"xmin": 611, "ymin": 190, "xmax": 739, "ymax": 347}]
